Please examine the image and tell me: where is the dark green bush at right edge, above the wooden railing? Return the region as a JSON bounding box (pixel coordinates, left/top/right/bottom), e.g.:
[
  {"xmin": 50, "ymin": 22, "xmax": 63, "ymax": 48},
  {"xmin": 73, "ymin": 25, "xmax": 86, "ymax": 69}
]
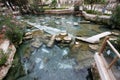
[{"xmin": 111, "ymin": 5, "xmax": 120, "ymax": 29}]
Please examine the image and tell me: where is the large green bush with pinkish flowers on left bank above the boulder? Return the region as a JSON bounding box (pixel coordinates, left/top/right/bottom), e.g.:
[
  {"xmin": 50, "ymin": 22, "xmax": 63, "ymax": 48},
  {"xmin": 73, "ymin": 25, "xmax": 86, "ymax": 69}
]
[{"xmin": 0, "ymin": 15, "xmax": 23, "ymax": 45}]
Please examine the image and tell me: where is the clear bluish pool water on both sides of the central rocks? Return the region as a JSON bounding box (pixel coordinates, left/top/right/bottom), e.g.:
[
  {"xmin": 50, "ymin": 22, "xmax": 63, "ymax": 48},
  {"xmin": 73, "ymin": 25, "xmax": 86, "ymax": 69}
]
[{"xmin": 5, "ymin": 15, "xmax": 110, "ymax": 80}]
